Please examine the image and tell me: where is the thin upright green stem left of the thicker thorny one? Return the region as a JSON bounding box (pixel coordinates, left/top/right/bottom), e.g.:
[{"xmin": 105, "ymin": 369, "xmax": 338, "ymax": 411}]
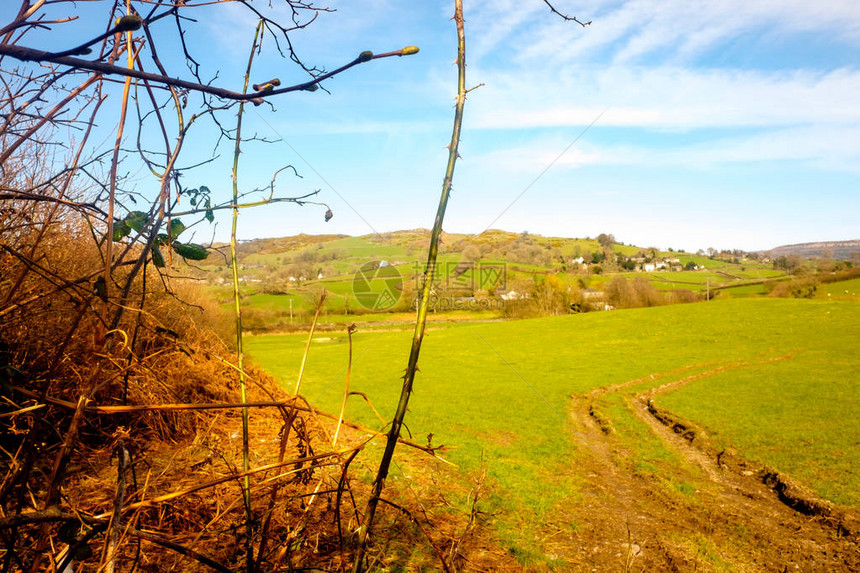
[{"xmin": 230, "ymin": 16, "xmax": 263, "ymax": 573}]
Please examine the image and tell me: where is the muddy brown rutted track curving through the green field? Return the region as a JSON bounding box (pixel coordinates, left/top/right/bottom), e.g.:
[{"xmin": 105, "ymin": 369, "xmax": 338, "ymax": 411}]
[{"xmin": 555, "ymin": 356, "xmax": 860, "ymax": 571}]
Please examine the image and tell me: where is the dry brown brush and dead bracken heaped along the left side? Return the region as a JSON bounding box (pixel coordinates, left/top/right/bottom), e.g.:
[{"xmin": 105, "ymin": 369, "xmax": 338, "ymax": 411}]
[{"xmin": 0, "ymin": 212, "xmax": 484, "ymax": 571}]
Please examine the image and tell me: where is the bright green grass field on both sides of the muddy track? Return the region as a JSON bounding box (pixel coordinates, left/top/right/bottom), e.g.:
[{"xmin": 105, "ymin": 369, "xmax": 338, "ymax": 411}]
[{"xmin": 247, "ymin": 299, "xmax": 860, "ymax": 547}]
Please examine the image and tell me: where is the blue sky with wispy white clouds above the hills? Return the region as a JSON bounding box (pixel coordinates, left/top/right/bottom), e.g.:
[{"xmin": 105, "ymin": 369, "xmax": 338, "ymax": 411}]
[{"xmin": 8, "ymin": 0, "xmax": 860, "ymax": 250}]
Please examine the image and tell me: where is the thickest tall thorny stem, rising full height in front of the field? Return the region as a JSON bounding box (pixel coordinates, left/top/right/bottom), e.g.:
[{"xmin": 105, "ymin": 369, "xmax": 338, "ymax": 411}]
[{"xmin": 353, "ymin": 0, "xmax": 466, "ymax": 573}]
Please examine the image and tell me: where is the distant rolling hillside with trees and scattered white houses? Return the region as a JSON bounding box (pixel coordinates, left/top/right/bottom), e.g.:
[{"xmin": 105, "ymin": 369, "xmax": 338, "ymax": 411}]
[{"xmin": 190, "ymin": 229, "xmax": 845, "ymax": 331}]
